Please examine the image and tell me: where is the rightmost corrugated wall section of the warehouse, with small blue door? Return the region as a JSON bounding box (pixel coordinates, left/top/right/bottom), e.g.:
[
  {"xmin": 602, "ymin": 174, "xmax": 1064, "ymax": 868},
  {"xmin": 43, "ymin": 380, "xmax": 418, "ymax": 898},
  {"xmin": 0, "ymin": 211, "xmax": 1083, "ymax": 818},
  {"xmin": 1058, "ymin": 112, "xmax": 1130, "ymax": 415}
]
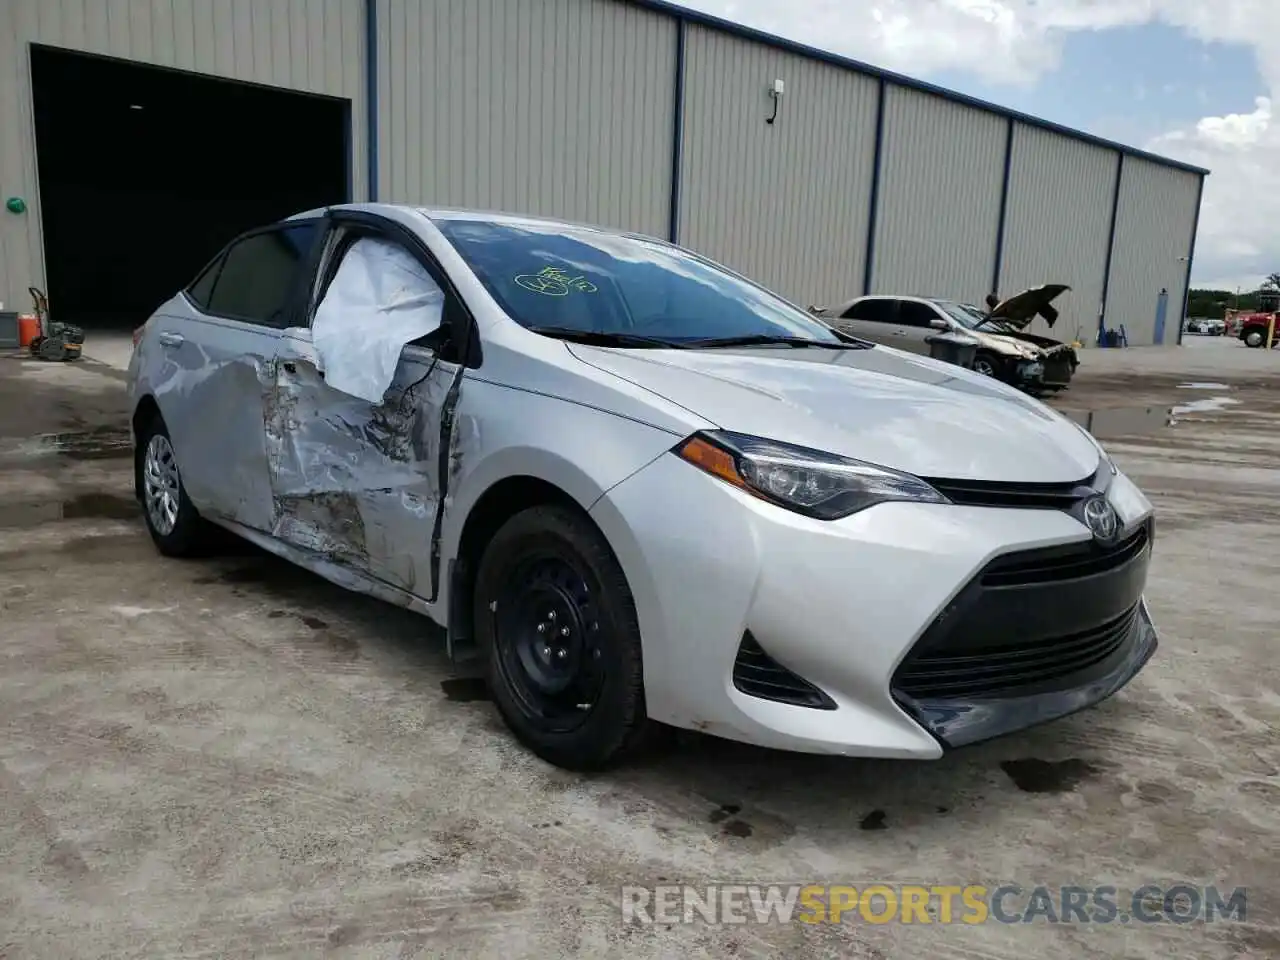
[{"xmin": 1106, "ymin": 156, "xmax": 1199, "ymax": 344}]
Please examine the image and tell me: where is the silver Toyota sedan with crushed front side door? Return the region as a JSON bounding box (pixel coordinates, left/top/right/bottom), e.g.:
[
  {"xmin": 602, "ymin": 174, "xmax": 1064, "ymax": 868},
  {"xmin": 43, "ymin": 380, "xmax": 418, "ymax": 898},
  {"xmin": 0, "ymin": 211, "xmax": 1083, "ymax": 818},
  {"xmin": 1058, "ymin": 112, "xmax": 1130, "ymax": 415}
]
[{"xmin": 129, "ymin": 205, "xmax": 1157, "ymax": 768}]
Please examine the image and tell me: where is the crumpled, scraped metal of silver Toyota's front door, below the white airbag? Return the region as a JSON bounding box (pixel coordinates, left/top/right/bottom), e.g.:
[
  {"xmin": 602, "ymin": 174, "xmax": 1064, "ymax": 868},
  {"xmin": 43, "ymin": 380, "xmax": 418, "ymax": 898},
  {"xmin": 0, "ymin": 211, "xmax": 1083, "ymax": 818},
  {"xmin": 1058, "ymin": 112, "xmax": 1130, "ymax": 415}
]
[{"xmin": 265, "ymin": 330, "xmax": 457, "ymax": 598}]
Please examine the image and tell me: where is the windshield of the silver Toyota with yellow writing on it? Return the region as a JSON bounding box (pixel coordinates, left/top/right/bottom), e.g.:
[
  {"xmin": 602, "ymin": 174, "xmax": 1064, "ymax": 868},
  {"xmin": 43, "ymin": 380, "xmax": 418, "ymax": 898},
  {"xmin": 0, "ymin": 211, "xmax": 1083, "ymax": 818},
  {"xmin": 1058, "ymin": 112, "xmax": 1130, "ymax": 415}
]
[{"xmin": 434, "ymin": 218, "xmax": 844, "ymax": 347}]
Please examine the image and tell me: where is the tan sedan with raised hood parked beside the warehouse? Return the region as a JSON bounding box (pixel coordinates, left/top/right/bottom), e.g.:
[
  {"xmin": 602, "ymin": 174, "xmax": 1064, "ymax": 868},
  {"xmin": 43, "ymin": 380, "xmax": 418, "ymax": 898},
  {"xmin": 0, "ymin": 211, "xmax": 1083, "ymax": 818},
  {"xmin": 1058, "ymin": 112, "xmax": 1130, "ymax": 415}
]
[{"xmin": 820, "ymin": 284, "xmax": 1080, "ymax": 393}]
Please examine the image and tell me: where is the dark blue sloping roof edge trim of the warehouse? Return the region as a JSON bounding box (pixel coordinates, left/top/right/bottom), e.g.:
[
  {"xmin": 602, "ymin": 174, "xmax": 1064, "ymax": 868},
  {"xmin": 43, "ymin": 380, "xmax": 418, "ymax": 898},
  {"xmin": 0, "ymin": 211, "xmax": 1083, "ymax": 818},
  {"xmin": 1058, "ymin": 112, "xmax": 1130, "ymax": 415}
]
[{"xmin": 626, "ymin": 0, "xmax": 1211, "ymax": 177}]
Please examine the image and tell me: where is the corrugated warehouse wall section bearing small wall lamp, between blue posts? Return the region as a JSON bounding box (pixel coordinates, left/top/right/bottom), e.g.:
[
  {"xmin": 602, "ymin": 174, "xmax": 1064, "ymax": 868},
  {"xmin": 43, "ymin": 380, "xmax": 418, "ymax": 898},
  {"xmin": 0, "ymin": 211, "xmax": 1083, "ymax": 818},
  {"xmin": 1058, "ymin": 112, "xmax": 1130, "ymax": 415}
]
[{"xmin": 678, "ymin": 27, "xmax": 878, "ymax": 306}]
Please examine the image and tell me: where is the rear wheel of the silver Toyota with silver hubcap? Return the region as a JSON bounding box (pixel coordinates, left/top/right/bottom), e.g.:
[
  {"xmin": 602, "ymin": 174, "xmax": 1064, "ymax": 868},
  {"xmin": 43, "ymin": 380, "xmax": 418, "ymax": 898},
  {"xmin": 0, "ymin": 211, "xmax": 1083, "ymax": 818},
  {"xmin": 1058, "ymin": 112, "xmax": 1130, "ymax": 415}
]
[{"xmin": 133, "ymin": 413, "xmax": 210, "ymax": 557}]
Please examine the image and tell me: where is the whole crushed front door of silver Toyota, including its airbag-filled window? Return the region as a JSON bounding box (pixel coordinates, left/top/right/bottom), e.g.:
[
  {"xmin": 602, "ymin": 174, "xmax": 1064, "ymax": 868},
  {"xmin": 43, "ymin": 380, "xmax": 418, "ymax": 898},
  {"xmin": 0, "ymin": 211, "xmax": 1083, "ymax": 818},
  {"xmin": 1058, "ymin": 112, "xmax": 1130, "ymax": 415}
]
[{"xmin": 268, "ymin": 241, "xmax": 457, "ymax": 598}]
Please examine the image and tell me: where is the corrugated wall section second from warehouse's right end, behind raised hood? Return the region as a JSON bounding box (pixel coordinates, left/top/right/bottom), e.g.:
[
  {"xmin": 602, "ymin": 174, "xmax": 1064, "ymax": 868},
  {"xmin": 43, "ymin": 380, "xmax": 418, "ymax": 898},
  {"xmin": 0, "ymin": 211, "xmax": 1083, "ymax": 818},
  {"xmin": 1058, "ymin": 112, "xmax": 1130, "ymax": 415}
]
[{"xmin": 1000, "ymin": 123, "xmax": 1119, "ymax": 344}]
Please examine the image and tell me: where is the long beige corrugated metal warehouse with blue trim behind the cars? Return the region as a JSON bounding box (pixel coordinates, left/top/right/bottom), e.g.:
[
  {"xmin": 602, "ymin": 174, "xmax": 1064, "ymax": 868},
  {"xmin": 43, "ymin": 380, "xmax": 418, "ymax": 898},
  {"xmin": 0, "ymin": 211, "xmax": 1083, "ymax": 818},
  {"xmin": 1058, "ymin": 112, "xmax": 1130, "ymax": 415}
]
[{"xmin": 0, "ymin": 0, "xmax": 1206, "ymax": 344}]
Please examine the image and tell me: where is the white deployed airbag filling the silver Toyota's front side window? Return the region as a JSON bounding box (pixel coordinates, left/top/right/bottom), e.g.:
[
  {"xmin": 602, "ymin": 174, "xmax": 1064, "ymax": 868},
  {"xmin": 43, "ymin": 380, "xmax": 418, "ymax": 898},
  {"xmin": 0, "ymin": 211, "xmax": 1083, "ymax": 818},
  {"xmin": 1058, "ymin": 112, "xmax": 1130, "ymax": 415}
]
[{"xmin": 311, "ymin": 237, "xmax": 444, "ymax": 403}]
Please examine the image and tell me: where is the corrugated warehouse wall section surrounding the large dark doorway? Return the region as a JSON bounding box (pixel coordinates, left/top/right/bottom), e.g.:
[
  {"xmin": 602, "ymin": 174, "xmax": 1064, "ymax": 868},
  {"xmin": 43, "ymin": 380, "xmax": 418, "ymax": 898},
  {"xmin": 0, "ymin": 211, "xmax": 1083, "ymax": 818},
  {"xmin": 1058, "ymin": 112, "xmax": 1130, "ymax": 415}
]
[{"xmin": 0, "ymin": 0, "xmax": 366, "ymax": 310}]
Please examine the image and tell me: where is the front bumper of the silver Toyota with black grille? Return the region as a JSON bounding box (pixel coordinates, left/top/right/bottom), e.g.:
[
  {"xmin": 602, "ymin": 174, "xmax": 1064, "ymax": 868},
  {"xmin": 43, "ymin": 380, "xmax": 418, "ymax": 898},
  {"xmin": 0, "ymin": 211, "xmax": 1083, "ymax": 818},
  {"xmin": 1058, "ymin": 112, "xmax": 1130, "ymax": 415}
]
[{"xmin": 591, "ymin": 456, "xmax": 1156, "ymax": 758}]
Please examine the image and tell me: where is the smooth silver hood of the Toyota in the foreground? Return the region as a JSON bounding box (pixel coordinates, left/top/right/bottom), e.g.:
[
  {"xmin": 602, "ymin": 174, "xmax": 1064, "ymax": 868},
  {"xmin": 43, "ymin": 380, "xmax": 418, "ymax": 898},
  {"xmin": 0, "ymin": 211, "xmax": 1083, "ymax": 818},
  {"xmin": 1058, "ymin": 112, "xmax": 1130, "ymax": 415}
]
[{"xmin": 567, "ymin": 343, "xmax": 1100, "ymax": 483}]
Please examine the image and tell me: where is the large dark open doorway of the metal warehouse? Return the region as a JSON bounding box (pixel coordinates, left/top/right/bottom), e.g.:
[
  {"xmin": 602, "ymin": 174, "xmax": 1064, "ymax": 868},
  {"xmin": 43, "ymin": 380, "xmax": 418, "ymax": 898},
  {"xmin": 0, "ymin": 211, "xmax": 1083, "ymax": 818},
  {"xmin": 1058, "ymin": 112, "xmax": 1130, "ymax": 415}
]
[{"xmin": 31, "ymin": 46, "xmax": 351, "ymax": 330}]
